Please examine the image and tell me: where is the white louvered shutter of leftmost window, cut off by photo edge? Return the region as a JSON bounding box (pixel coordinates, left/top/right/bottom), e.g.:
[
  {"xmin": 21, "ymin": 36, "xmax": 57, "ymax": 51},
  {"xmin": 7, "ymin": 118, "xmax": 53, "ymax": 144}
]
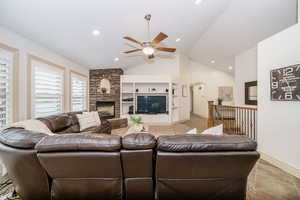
[{"xmin": 0, "ymin": 49, "xmax": 13, "ymax": 127}]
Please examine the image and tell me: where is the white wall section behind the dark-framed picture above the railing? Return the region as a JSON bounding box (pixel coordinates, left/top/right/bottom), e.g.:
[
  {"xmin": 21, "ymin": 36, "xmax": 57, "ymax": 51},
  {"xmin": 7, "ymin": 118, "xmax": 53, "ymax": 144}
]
[{"xmin": 234, "ymin": 46, "xmax": 257, "ymax": 106}]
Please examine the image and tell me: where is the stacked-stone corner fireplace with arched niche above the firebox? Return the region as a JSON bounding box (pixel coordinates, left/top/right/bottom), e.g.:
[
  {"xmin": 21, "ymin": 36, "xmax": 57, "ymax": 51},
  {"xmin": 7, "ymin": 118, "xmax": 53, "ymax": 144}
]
[{"xmin": 89, "ymin": 68, "xmax": 123, "ymax": 118}]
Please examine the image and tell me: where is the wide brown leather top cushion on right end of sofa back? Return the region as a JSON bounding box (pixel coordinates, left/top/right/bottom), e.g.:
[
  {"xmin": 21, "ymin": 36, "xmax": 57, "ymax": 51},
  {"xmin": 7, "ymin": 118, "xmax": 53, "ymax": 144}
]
[{"xmin": 157, "ymin": 134, "xmax": 257, "ymax": 152}]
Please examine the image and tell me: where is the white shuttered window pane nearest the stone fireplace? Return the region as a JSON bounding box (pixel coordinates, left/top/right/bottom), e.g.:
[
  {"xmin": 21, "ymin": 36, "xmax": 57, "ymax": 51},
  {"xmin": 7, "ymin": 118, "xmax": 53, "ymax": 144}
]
[{"xmin": 71, "ymin": 72, "xmax": 87, "ymax": 111}]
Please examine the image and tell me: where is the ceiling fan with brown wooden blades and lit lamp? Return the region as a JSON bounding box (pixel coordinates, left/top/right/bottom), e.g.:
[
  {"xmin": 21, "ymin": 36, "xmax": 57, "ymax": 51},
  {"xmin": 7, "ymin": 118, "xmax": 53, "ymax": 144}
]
[{"xmin": 123, "ymin": 14, "xmax": 176, "ymax": 59}]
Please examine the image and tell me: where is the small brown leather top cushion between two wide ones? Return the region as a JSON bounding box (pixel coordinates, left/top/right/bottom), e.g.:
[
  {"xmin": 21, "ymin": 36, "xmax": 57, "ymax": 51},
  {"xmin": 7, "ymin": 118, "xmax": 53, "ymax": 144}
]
[{"xmin": 122, "ymin": 133, "xmax": 156, "ymax": 150}]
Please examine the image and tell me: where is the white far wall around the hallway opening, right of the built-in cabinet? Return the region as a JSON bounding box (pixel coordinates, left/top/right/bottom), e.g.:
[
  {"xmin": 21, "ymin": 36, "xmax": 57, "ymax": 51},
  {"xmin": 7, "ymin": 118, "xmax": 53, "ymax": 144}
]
[{"xmin": 188, "ymin": 61, "xmax": 234, "ymax": 118}]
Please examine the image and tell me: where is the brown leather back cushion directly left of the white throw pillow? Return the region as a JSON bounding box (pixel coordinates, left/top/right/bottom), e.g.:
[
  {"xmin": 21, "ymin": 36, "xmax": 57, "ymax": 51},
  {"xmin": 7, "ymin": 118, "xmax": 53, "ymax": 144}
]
[{"xmin": 37, "ymin": 114, "xmax": 73, "ymax": 133}]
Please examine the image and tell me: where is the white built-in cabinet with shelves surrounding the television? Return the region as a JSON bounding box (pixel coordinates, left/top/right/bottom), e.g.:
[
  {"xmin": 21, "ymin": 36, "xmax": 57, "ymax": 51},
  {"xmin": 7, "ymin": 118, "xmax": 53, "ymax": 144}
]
[{"xmin": 120, "ymin": 75, "xmax": 179, "ymax": 124}]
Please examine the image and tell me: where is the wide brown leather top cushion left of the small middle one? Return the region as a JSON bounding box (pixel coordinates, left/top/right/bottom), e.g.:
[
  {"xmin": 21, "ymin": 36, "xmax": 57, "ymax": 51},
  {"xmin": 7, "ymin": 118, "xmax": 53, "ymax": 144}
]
[{"xmin": 35, "ymin": 133, "xmax": 121, "ymax": 152}]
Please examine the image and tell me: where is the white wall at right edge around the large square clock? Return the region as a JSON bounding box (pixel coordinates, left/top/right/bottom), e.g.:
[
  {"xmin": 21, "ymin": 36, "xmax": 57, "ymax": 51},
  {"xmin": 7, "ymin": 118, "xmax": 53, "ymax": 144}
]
[{"xmin": 258, "ymin": 24, "xmax": 300, "ymax": 171}]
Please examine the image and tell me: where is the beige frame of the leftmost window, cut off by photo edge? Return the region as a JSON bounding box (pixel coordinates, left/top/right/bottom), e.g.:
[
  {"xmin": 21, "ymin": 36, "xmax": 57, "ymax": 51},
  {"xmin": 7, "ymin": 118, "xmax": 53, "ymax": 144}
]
[{"xmin": 0, "ymin": 43, "xmax": 19, "ymax": 123}]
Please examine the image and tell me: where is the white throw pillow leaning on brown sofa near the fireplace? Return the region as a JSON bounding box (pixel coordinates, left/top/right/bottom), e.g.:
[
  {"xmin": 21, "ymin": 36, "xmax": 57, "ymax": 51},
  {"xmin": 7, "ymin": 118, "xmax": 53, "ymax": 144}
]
[{"xmin": 76, "ymin": 111, "xmax": 101, "ymax": 131}]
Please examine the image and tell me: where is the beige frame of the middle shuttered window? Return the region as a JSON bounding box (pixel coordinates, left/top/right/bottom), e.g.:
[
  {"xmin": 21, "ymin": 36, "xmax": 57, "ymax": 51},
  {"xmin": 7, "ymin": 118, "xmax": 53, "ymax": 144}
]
[{"xmin": 27, "ymin": 54, "xmax": 67, "ymax": 119}]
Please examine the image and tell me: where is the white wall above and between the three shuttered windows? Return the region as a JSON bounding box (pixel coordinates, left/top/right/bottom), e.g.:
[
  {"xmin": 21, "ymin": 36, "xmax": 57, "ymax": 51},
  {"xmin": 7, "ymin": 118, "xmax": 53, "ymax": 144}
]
[{"xmin": 0, "ymin": 27, "xmax": 89, "ymax": 120}]
